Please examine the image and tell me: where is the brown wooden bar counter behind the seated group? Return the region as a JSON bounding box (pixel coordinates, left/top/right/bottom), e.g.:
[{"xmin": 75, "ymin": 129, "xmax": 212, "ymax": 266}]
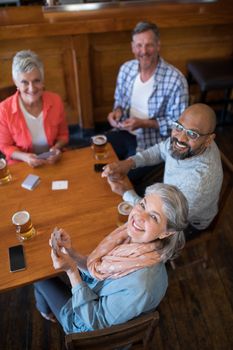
[{"xmin": 0, "ymin": 0, "xmax": 233, "ymax": 128}]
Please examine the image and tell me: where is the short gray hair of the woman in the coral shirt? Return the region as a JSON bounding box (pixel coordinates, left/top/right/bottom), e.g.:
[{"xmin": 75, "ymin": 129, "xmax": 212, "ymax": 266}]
[{"xmin": 12, "ymin": 50, "xmax": 44, "ymax": 80}]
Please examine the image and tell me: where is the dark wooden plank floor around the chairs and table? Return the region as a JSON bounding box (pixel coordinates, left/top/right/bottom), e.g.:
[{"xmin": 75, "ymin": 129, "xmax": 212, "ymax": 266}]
[{"xmin": 0, "ymin": 126, "xmax": 233, "ymax": 350}]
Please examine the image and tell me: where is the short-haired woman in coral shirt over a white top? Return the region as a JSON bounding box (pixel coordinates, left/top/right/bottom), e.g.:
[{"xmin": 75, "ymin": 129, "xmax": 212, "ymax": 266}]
[{"xmin": 0, "ymin": 50, "xmax": 69, "ymax": 167}]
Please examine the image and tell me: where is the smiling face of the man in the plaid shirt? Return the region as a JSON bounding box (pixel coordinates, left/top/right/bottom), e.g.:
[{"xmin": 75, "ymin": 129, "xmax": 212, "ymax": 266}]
[{"xmin": 132, "ymin": 30, "xmax": 160, "ymax": 70}]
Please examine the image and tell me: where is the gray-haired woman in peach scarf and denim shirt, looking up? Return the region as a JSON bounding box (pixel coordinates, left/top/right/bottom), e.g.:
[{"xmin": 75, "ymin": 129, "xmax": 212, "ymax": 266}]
[{"xmin": 34, "ymin": 184, "xmax": 188, "ymax": 333}]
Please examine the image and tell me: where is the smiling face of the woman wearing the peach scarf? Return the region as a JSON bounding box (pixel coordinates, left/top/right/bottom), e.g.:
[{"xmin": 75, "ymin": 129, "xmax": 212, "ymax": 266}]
[{"xmin": 127, "ymin": 194, "xmax": 168, "ymax": 243}]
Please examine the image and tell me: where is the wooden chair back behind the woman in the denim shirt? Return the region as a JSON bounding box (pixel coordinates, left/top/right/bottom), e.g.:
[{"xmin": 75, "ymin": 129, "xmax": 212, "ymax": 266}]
[{"xmin": 65, "ymin": 311, "xmax": 159, "ymax": 350}]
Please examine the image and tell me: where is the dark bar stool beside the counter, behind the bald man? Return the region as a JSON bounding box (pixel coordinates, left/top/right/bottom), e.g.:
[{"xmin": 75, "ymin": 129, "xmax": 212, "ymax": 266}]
[{"xmin": 187, "ymin": 58, "xmax": 233, "ymax": 124}]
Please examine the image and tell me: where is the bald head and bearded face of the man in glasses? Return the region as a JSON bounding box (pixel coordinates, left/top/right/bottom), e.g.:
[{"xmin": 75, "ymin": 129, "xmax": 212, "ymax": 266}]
[{"xmin": 171, "ymin": 104, "xmax": 215, "ymax": 159}]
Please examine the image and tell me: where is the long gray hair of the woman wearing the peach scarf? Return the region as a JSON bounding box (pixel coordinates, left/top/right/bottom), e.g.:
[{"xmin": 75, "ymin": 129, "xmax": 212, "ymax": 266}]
[{"xmin": 145, "ymin": 183, "xmax": 188, "ymax": 262}]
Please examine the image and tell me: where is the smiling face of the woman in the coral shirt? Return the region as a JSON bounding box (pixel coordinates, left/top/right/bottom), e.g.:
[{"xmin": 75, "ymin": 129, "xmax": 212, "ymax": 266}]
[{"xmin": 15, "ymin": 68, "xmax": 44, "ymax": 106}]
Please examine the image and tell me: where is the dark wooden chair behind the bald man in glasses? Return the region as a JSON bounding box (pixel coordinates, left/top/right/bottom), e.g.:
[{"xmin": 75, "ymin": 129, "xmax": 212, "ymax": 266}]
[{"xmin": 170, "ymin": 152, "xmax": 233, "ymax": 269}]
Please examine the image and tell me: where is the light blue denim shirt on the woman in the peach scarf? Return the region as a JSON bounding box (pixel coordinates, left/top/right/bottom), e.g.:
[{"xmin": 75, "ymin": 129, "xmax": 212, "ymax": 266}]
[{"xmin": 59, "ymin": 263, "xmax": 168, "ymax": 333}]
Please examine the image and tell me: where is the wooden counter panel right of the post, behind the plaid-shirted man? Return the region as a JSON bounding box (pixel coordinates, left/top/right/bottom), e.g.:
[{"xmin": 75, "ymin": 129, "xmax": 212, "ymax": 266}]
[{"xmin": 90, "ymin": 25, "xmax": 233, "ymax": 122}]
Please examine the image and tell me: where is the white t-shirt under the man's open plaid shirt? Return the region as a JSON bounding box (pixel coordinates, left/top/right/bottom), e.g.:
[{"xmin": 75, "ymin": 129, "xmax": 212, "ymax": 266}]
[{"xmin": 130, "ymin": 73, "xmax": 154, "ymax": 119}]
